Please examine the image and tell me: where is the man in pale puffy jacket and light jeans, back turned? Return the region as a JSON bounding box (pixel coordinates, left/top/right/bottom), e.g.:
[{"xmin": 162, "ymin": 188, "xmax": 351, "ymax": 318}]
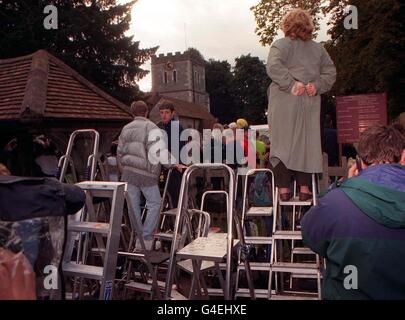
[{"xmin": 117, "ymin": 101, "xmax": 182, "ymax": 250}]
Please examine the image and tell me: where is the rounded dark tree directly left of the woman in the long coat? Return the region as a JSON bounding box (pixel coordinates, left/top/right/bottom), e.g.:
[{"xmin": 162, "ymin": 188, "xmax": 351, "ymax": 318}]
[{"xmin": 233, "ymin": 54, "xmax": 271, "ymax": 124}]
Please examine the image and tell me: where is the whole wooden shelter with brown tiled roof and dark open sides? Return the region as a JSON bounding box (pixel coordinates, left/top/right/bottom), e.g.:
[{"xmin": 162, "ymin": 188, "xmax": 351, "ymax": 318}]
[{"xmin": 0, "ymin": 50, "xmax": 132, "ymax": 174}]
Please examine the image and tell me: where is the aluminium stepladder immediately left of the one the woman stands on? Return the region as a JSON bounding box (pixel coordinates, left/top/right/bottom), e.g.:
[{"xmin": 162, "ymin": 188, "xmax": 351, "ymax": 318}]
[{"xmin": 235, "ymin": 169, "xmax": 278, "ymax": 299}]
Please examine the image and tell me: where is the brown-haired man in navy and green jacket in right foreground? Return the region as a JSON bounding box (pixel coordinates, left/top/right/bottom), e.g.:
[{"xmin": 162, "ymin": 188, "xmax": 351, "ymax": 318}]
[{"xmin": 301, "ymin": 126, "xmax": 405, "ymax": 299}]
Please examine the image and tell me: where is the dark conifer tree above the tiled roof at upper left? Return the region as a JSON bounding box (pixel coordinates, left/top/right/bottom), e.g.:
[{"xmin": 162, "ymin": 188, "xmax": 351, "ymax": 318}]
[{"xmin": 0, "ymin": 0, "xmax": 157, "ymax": 103}]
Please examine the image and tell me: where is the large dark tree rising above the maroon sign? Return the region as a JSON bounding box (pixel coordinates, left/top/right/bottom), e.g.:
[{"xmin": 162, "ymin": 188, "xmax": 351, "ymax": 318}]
[{"xmin": 326, "ymin": 0, "xmax": 405, "ymax": 118}]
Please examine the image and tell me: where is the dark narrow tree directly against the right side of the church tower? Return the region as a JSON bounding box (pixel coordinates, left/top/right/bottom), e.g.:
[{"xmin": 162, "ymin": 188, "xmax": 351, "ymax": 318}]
[{"xmin": 205, "ymin": 59, "xmax": 236, "ymax": 123}]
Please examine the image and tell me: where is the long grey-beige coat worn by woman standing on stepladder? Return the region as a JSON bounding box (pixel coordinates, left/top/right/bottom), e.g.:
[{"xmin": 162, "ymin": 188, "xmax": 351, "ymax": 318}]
[{"xmin": 267, "ymin": 38, "xmax": 336, "ymax": 173}]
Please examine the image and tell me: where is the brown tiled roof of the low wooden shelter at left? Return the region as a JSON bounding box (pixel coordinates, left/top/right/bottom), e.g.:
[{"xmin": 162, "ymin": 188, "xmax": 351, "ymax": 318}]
[{"xmin": 0, "ymin": 50, "xmax": 132, "ymax": 121}]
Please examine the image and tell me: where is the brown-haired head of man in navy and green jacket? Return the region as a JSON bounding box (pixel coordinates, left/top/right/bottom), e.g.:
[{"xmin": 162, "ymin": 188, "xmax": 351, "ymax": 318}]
[{"xmin": 357, "ymin": 126, "xmax": 405, "ymax": 167}]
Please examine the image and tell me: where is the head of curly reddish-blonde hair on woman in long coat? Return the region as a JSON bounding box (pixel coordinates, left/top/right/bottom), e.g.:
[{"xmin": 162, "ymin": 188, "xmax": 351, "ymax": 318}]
[{"xmin": 281, "ymin": 9, "xmax": 315, "ymax": 41}]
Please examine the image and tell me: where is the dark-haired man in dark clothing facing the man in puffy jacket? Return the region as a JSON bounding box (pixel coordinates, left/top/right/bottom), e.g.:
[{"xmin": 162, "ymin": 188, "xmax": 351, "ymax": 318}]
[{"xmin": 157, "ymin": 101, "xmax": 185, "ymax": 207}]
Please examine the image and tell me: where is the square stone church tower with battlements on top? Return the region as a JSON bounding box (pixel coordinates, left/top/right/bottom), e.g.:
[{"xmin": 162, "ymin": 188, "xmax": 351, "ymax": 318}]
[{"xmin": 152, "ymin": 49, "xmax": 210, "ymax": 111}]
